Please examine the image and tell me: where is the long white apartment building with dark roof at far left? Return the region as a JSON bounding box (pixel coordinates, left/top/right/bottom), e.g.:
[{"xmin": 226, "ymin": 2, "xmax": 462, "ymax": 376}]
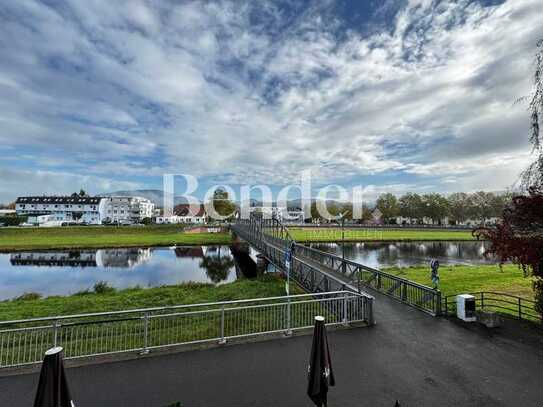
[{"xmin": 15, "ymin": 194, "xmax": 101, "ymax": 225}]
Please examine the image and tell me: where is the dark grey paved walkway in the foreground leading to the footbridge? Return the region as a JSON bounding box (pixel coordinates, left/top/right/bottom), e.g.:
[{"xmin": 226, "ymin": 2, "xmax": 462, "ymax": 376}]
[{"xmin": 0, "ymin": 296, "xmax": 543, "ymax": 407}]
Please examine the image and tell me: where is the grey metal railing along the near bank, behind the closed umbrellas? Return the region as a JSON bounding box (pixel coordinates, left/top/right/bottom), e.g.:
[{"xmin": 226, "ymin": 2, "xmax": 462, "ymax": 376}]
[{"xmin": 0, "ymin": 291, "xmax": 371, "ymax": 368}]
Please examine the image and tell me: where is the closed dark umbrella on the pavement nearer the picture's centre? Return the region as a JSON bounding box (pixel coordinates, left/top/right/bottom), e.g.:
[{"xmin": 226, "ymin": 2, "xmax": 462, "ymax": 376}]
[{"xmin": 307, "ymin": 317, "xmax": 335, "ymax": 407}]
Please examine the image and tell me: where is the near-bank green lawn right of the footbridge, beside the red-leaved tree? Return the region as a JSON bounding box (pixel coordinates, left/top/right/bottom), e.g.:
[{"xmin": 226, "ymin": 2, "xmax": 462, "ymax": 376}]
[{"xmin": 383, "ymin": 265, "xmax": 534, "ymax": 300}]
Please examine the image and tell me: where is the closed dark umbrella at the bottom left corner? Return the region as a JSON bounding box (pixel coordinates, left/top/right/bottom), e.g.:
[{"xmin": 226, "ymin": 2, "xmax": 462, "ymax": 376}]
[{"xmin": 34, "ymin": 347, "xmax": 75, "ymax": 407}]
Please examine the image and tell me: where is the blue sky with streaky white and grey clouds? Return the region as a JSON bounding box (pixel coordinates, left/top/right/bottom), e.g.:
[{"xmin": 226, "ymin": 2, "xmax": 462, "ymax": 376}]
[{"xmin": 0, "ymin": 0, "xmax": 543, "ymax": 202}]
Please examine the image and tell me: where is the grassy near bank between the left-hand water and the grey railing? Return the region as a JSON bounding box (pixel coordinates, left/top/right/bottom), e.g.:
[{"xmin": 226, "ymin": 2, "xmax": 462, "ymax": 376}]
[{"xmin": 0, "ymin": 274, "xmax": 303, "ymax": 321}]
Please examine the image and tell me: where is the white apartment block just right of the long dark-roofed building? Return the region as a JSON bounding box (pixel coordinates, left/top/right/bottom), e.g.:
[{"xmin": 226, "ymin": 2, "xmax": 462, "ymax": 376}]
[{"xmin": 99, "ymin": 196, "xmax": 155, "ymax": 224}]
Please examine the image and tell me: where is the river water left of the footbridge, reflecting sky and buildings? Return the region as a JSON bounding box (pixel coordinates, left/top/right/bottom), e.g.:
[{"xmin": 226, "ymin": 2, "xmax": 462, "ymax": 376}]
[{"xmin": 0, "ymin": 246, "xmax": 255, "ymax": 300}]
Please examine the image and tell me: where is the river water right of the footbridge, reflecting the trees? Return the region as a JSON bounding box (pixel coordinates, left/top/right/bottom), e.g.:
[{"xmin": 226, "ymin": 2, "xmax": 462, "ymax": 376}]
[{"xmin": 311, "ymin": 241, "xmax": 495, "ymax": 268}]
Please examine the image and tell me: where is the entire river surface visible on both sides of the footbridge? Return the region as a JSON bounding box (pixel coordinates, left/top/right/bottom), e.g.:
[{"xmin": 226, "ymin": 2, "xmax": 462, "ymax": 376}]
[{"xmin": 0, "ymin": 242, "xmax": 491, "ymax": 300}]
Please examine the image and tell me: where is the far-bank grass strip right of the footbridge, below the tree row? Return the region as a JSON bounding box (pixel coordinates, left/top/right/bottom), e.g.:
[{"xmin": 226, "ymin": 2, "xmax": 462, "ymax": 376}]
[{"xmin": 289, "ymin": 227, "xmax": 474, "ymax": 242}]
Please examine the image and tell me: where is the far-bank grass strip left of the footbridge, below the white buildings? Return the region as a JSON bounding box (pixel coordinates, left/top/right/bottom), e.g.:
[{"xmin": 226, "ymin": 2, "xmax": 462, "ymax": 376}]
[{"xmin": 0, "ymin": 225, "xmax": 230, "ymax": 251}]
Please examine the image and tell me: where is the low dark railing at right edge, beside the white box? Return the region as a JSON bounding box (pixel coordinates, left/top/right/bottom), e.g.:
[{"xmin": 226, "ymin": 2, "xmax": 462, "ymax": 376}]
[{"xmin": 443, "ymin": 291, "xmax": 543, "ymax": 323}]
